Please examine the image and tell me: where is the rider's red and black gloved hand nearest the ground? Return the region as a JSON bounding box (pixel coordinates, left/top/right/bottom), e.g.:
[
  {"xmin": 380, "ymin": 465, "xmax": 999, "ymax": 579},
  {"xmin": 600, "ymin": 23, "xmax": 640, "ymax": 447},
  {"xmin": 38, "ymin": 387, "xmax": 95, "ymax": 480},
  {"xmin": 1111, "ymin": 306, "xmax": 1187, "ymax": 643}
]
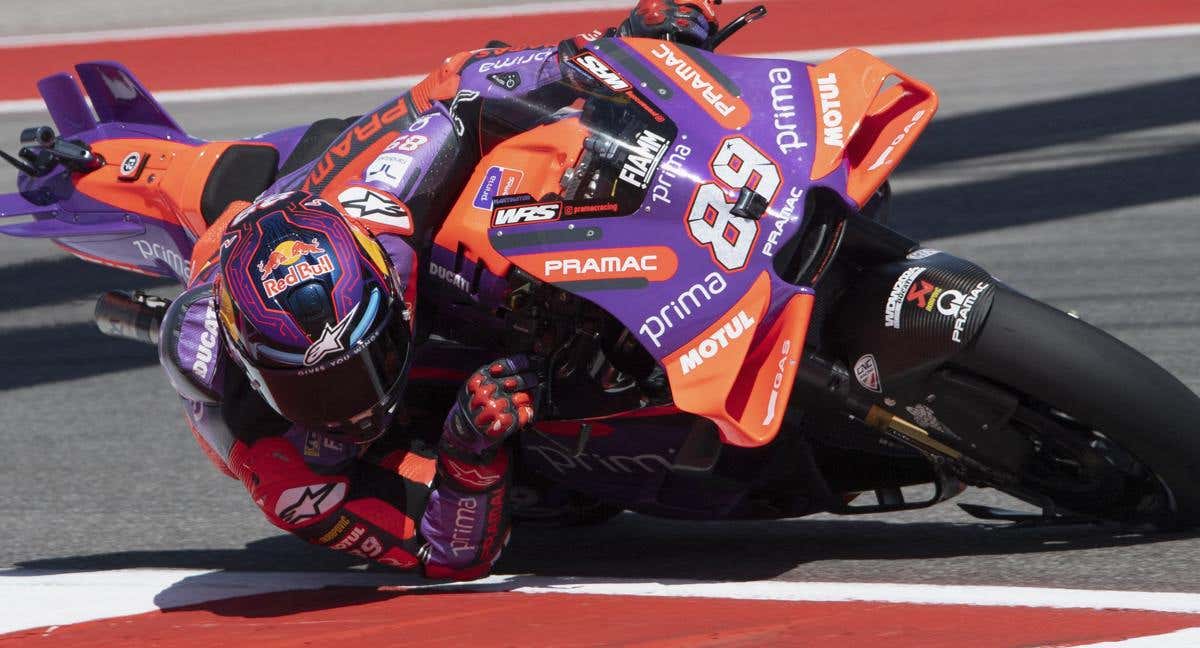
[{"xmin": 442, "ymin": 355, "xmax": 539, "ymax": 458}]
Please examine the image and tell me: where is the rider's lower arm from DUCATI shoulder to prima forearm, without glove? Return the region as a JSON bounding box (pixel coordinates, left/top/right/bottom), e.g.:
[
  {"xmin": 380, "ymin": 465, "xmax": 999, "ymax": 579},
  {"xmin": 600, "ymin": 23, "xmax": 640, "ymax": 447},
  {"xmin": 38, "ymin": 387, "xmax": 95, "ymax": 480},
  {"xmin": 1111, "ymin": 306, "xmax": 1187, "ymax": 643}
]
[{"xmin": 160, "ymin": 276, "xmax": 513, "ymax": 578}]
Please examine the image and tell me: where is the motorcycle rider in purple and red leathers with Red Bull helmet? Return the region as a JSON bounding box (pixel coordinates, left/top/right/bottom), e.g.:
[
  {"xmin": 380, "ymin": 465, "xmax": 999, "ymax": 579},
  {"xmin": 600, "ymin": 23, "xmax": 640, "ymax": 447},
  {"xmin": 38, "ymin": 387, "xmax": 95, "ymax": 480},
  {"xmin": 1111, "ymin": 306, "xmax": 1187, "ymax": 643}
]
[{"xmin": 160, "ymin": 0, "xmax": 719, "ymax": 580}]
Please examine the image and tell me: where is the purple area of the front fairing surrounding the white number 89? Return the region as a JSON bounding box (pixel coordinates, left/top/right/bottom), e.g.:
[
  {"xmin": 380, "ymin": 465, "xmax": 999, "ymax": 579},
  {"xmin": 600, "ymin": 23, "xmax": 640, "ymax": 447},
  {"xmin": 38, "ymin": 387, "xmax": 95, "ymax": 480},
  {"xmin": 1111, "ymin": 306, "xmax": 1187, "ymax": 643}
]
[{"xmin": 477, "ymin": 40, "xmax": 835, "ymax": 361}]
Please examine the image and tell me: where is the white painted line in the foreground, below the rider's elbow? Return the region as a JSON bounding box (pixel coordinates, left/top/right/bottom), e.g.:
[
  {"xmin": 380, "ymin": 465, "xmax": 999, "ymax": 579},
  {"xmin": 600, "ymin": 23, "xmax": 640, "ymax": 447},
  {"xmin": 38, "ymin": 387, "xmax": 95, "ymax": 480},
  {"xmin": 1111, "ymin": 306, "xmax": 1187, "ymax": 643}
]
[{"xmin": 0, "ymin": 569, "xmax": 1200, "ymax": 633}]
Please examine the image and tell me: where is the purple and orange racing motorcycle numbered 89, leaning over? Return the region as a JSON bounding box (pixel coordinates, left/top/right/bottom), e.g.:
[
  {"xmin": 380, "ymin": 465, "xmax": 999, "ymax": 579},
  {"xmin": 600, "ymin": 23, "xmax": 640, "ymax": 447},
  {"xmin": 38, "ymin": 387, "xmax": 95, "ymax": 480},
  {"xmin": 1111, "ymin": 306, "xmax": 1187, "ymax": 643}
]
[{"xmin": 0, "ymin": 7, "xmax": 1200, "ymax": 527}]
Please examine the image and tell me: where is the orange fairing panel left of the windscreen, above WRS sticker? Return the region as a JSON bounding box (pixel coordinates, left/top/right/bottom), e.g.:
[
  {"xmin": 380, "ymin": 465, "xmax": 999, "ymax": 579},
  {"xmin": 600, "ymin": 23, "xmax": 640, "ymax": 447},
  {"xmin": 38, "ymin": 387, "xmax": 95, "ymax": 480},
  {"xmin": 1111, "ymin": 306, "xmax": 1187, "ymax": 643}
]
[{"xmin": 433, "ymin": 119, "xmax": 588, "ymax": 277}]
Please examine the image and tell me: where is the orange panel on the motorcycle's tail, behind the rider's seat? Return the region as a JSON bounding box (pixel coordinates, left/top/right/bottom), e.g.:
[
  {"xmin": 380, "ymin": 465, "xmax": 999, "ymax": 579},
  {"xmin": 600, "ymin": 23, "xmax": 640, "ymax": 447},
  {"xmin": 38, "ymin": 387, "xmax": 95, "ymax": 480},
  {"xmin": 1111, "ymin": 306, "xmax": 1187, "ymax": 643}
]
[{"xmin": 76, "ymin": 138, "xmax": 276, "ymax": 236}]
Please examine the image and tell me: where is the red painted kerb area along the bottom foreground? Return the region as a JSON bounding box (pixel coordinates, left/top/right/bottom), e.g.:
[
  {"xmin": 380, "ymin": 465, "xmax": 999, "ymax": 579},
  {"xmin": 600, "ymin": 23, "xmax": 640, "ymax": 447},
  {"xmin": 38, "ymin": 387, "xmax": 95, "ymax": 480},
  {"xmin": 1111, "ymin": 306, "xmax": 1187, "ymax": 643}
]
[{"xmin": 0, "ymin": 588, "xmax": 1200, "ymax": 648}]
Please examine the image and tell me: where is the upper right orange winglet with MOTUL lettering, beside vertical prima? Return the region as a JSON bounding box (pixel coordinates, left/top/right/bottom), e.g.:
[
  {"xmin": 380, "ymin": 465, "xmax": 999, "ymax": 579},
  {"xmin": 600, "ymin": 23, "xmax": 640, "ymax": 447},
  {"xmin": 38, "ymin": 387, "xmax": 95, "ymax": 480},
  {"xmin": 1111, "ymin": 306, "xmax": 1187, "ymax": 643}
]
[{"xmin": 809, "ymin": 49, "xmax": 937, "ymax": 205}]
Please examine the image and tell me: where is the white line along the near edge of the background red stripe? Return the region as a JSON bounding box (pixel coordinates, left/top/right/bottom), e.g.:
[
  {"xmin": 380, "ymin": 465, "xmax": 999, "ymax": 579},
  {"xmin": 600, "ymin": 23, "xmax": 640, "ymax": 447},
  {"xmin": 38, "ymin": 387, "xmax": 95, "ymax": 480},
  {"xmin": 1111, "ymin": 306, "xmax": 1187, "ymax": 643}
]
[{"xmin": 0, "ymin": 22, "xmax": 1200, "ymax": 115}]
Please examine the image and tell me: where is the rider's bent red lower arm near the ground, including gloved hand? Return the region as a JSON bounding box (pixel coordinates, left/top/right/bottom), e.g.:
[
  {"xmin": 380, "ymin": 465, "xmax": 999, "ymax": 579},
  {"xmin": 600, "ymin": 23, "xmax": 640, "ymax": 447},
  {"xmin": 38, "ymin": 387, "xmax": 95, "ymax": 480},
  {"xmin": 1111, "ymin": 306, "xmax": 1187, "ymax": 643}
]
[{"xmin": 216, "ymin": 360, "xmax": 536, "ymax": 580}]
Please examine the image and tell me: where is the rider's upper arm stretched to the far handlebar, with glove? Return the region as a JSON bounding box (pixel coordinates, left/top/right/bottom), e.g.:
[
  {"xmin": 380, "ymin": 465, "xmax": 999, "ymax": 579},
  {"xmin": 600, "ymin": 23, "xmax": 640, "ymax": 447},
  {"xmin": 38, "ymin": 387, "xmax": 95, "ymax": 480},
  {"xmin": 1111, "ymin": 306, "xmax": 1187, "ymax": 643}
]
[{"xmin": 333, "ymin": 0, "xmax": 716, "ymax": 240}]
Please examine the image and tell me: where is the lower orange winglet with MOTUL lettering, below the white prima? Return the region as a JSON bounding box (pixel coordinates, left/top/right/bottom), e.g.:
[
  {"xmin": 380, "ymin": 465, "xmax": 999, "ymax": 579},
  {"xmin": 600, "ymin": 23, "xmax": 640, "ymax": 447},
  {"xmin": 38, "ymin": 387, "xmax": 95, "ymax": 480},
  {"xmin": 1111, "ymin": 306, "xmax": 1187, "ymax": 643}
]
[{"xmin": 662, "ymin": 272, "xmax": 812, "ymax": 448}]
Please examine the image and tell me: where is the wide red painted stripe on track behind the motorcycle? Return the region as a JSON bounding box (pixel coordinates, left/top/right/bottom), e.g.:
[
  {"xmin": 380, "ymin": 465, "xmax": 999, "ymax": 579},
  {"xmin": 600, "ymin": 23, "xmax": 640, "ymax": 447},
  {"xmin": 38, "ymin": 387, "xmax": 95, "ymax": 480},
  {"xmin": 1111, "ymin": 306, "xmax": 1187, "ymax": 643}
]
[{"xmin": 0, "ymin": 0, "xmax": 1200, "ymax": 100}]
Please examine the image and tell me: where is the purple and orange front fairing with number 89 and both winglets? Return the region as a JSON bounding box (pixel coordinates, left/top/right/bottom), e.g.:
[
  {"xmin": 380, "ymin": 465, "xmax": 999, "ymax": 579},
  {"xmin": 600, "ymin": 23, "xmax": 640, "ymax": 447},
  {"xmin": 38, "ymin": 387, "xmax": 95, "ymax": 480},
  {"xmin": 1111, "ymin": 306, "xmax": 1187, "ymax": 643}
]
[{"xmin": 436, "ymin": 38, "xmax": 936, "ymax": 446}]
